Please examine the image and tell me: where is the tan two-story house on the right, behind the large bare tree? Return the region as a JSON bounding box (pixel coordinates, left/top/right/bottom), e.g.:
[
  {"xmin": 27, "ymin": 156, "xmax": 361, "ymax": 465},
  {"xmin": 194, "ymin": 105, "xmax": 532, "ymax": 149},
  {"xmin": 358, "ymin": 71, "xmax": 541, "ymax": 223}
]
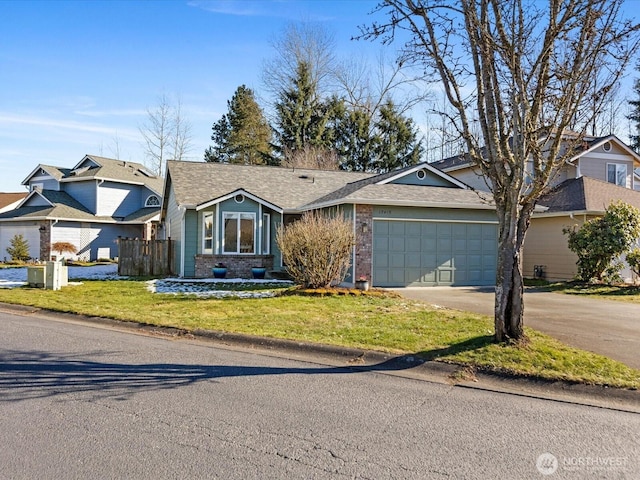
[{"xmin": 431, "ymin": 135, "xmax": 640, "ymax": 280}]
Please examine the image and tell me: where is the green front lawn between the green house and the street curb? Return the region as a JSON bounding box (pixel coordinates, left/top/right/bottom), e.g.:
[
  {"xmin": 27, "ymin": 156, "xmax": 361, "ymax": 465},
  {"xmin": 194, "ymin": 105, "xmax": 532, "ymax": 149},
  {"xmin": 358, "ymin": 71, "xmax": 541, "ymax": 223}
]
[{"xmin": 0, "ymin": 280, "xmax": 640, "ymax": 389}]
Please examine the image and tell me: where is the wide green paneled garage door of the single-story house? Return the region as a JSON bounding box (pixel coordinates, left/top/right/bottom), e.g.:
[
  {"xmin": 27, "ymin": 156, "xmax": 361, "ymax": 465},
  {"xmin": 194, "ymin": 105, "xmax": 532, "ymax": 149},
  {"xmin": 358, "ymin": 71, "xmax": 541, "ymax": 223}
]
[{"xmin": 373, "ymin": 220, "xmax": 498, "ymax": 287}]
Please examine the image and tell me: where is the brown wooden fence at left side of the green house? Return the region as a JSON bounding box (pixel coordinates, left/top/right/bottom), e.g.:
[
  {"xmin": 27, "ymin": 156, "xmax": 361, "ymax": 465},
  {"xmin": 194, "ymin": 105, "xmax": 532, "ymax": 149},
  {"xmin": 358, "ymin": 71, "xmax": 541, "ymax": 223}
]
[{"xmin": 118, "ymin": 237, "xmax": 175, "ymax": 277}]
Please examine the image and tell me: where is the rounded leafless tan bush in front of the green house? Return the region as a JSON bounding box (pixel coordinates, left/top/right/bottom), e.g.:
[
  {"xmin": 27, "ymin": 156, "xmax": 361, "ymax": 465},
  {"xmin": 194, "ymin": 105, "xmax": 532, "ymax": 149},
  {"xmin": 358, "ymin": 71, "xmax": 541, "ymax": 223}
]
[{"xmin": 276, "ymin": 212, "xmax": 355, "ymax": 288}]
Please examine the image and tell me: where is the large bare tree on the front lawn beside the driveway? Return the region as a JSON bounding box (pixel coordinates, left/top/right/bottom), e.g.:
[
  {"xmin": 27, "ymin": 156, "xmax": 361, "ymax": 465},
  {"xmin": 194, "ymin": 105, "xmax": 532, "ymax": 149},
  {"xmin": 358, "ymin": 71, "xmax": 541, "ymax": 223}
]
[{"xmin": 363, "ymin": 0, "xmax": 639, "ymax": 341}]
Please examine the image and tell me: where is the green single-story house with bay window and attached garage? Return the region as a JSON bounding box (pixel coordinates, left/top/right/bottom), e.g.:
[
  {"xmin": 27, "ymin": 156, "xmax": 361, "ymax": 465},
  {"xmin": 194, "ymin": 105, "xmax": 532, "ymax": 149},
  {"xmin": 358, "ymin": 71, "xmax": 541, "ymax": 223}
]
[{"xmin": 161, "ymin": 161, "xmax": 498, "ymax": 287}]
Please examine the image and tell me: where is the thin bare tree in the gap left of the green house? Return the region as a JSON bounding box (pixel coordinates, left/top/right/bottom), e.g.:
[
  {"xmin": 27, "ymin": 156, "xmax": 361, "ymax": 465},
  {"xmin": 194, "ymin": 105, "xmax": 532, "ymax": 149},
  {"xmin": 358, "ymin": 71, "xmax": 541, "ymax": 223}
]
[{"xmin": 139, "ymin": 94, "xmax": 191, "ymax": 176}]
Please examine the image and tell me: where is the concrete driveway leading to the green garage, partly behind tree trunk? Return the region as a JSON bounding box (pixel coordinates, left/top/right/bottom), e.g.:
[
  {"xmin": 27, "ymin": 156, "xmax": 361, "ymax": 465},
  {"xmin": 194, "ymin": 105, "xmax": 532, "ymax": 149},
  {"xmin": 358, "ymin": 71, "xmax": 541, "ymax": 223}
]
[{"xmin": 392, "ymin": 287, "xmax": 640, "ymax": 369}]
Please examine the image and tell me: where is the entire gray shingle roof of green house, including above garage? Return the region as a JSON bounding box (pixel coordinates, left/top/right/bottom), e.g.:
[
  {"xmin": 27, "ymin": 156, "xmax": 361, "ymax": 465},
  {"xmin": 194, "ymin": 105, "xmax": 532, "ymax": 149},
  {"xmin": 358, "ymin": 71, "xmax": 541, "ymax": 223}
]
[{"xmin": 167, "ymin": 162, "xmax": 494, "ymax": 212}]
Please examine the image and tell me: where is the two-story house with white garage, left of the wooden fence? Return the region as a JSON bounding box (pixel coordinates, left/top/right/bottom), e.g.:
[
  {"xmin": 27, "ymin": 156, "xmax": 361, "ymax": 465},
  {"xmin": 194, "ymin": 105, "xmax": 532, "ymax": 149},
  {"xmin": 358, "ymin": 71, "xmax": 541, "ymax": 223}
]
[{"xmin": 0, "ymin": 155, "xmax": 163, "ymax": 260}]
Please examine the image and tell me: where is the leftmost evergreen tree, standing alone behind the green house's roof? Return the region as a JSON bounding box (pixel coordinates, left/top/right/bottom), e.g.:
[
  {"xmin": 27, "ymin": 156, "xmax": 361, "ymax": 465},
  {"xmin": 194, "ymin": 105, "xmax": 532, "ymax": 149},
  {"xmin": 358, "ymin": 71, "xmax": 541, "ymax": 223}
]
[{"xmin": 204, "ymin": 85, "xmax": 271, "ymax": 165}]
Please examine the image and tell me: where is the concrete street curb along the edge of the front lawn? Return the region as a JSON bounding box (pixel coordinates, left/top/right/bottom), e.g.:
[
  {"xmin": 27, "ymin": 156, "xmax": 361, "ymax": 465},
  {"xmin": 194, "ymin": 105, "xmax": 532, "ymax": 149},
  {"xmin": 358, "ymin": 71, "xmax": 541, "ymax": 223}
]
[{"xmin": 0, "ymin": 303, "xmax": 640, "ymax": 413}]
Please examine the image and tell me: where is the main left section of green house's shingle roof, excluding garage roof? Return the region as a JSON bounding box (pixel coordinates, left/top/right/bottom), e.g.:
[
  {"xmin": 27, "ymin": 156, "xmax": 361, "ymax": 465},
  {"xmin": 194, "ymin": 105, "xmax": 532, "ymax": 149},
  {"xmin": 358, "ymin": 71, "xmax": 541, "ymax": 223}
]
[{"xmin": 167, "ymin": 161, "xmax": 373, "ymax": 211}]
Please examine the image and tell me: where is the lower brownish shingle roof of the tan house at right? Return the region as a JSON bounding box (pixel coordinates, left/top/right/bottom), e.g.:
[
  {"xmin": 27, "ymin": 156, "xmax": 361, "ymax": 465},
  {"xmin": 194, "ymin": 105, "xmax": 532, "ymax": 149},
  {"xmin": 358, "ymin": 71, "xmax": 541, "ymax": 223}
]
[{"xmin": 538, "ymin": 177, "xmax": 640, "ymax": 213}]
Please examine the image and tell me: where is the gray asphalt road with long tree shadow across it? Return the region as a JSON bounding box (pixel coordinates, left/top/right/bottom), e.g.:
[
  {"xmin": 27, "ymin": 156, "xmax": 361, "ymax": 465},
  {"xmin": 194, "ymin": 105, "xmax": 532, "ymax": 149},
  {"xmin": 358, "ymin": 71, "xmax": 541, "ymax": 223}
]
[{"xmin": 0, "ymin": 313, "xmax": 640, "ymax": 480}]
